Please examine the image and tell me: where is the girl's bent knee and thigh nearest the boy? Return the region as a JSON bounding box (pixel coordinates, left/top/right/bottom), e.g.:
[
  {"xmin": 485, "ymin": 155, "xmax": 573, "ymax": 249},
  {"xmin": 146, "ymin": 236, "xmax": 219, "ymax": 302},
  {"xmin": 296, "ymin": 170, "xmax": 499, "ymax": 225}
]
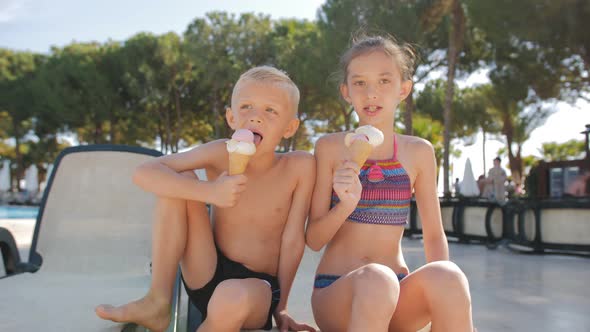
[{"xmin": 312, "ymin": 264, "xmax": 399, "ymax": 332}]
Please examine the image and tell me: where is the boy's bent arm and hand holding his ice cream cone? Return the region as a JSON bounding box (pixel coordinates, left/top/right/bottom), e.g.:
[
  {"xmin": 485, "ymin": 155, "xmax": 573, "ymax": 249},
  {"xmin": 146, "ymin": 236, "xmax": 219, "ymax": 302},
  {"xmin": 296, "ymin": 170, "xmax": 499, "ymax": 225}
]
[{"xmin": 133, "ymin": 140, "xmax": 245, "ymax": 205}]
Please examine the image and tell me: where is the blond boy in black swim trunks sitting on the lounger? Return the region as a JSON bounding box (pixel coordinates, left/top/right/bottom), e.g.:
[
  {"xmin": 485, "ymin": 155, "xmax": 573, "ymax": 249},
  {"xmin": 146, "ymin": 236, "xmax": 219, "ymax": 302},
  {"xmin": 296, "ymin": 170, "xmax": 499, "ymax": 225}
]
[{"xmin": 96, "ymin": 67, "xmax": 315, "ymax": 331}]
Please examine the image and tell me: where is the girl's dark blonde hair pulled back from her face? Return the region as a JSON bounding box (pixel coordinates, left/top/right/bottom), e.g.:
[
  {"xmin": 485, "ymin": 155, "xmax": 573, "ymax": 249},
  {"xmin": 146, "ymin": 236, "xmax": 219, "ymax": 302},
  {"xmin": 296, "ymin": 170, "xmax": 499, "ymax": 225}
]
[{"xmin": 340, "ymin": 35, "xmax": 417, "ymax": 84}]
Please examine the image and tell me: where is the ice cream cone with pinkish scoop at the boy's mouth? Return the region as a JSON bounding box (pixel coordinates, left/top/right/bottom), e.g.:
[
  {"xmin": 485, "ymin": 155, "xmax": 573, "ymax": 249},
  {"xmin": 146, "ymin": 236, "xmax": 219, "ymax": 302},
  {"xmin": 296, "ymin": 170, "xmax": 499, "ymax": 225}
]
[{"xmin": 226, "ymin": 129, "xmax": 256, "ymax": 175}]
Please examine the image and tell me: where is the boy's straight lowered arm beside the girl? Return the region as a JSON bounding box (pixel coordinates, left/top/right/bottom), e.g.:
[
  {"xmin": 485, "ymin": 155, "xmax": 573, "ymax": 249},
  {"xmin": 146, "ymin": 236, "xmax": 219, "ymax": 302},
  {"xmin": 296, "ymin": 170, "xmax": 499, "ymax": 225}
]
[{"xmin": 275, "ymin": 152, "xmax": 315, "ymax": 323}]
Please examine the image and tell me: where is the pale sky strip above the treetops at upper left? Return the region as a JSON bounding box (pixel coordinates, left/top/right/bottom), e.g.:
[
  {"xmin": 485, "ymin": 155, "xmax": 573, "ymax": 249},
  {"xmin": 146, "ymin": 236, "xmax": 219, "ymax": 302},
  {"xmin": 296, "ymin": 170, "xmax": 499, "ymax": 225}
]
[{"xmin": 0, "ymin": 0, "xmax": 323, "ymax": 52}]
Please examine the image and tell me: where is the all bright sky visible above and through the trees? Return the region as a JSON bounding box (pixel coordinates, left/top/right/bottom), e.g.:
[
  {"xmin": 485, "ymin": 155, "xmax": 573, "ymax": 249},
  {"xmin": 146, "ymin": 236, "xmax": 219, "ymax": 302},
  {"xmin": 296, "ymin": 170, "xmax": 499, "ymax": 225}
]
[{"xmin": 0, "ymin": 0, "xmax": 590, "ymax": 187}]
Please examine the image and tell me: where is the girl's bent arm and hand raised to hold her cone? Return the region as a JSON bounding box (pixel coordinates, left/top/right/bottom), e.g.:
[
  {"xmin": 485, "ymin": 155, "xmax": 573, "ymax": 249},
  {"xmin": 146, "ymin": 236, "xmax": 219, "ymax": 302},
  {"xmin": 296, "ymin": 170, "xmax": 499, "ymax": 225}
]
[{"xmin": 305, "ymin": 135, "xmax": 362, "ymax": 251}]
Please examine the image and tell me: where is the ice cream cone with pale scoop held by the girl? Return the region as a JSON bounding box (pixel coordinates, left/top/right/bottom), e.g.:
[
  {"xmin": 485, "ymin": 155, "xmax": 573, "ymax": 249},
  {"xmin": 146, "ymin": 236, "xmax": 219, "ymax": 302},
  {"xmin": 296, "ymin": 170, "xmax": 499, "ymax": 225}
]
[{"xmin": 344, "ymin": 125, "xmax": 383, "ymax": 167}]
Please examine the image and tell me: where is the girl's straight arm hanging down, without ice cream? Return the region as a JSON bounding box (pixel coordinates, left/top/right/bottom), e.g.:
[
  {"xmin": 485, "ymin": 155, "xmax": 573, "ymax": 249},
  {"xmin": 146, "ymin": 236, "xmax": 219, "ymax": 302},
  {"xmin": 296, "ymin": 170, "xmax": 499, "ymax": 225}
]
[{"xmin": 413, "ymin": 140, "xmax": 449, "ymax": 262}]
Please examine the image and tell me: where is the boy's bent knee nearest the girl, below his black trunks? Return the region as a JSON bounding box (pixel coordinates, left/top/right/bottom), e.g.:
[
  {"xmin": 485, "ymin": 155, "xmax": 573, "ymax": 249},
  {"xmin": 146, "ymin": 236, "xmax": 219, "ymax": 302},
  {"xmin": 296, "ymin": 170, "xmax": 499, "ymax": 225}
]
[{"xmin": 198, "ymin": 278, "xmax": 272, "ymax": 332}]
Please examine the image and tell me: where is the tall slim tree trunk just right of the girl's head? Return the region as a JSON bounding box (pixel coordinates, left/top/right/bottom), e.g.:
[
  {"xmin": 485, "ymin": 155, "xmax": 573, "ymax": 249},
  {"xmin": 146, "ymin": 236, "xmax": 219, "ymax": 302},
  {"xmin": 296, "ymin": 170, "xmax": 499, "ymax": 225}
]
[{"xmin": 443, "ymin": 0, "xmax": 465, "ymax": 196}]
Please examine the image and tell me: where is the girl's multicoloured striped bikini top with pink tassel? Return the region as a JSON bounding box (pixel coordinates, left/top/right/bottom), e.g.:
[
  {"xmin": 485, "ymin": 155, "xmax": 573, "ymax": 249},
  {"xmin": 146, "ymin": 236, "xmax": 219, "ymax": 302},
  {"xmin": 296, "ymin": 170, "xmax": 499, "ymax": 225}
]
[{"xmin": 331, "ymin": 136, "xmax": 412, "ymax": 225}]
